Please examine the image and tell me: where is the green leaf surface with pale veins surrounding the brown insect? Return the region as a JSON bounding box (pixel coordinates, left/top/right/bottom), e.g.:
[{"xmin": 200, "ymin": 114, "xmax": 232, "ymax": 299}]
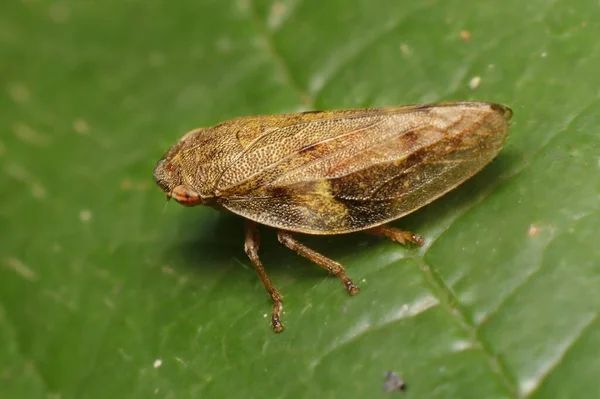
[{"xmin": 0, "ymin": 0, "xmax": 600, "ymax": 399}]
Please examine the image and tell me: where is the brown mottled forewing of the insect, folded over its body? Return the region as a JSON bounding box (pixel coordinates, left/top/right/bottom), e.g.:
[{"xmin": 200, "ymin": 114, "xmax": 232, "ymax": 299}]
[{"xmin": 218, "ymin": 103, "xmax": 508, "ymax": 234}]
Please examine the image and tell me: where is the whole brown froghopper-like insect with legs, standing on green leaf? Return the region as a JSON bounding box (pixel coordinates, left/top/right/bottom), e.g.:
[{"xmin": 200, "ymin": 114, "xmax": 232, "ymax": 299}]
[{"xmin": 154, "ymin": 102, "xmax": 512, "ymax": 332}]
